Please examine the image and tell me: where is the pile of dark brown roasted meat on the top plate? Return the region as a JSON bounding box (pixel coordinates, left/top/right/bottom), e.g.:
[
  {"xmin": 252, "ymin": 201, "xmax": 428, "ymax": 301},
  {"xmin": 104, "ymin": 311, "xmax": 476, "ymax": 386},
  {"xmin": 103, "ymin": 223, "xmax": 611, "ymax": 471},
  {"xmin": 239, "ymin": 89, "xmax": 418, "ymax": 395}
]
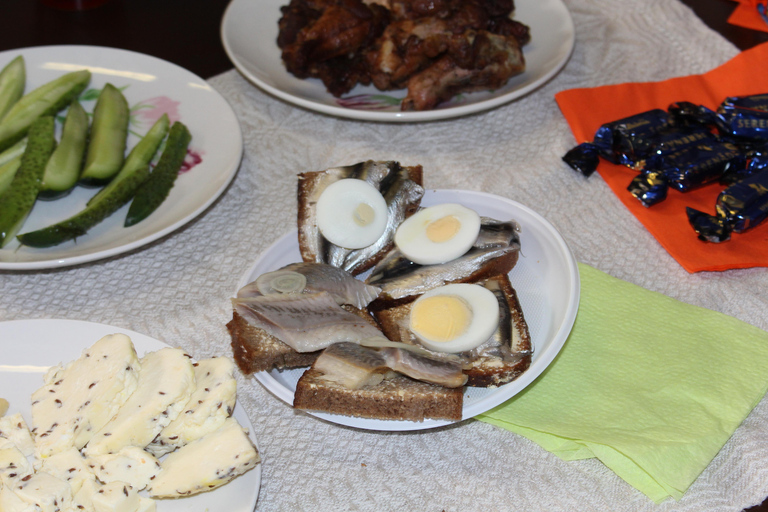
[{"xmin": 278, "ymin": 0, "xmax": 530, "ymax": 110}]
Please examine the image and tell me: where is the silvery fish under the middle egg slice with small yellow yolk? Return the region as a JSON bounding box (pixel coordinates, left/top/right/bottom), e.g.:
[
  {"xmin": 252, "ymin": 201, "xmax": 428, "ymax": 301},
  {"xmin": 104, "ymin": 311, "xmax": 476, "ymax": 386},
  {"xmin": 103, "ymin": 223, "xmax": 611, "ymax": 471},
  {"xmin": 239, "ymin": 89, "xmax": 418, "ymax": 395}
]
[{"xmin": 366, "ymin": 218, "xmax": 520, "ymax": 300}]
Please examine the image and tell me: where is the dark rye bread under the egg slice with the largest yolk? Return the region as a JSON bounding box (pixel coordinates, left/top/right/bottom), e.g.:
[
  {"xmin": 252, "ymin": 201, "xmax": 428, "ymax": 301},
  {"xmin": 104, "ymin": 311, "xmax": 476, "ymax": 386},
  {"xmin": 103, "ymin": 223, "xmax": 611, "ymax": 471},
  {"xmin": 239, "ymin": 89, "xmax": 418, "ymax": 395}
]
[{"xmin": 372, "ymin": 274, "xmax": 533, "ymax": 387}]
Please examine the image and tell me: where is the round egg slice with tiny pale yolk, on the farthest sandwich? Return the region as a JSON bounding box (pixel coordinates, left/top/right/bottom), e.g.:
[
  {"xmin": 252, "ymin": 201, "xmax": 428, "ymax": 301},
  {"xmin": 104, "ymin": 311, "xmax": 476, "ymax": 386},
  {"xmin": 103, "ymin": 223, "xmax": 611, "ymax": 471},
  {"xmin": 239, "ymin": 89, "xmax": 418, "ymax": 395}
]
[{"xmin": 316, "ymin": 178, "xmax": 388, "ymax": 249}]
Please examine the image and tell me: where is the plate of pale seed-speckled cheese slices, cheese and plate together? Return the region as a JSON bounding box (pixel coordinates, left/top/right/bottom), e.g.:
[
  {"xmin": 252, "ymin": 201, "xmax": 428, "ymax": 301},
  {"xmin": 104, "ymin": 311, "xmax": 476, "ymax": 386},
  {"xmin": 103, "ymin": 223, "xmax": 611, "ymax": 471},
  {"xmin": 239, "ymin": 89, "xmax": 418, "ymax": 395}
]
[{"xmin": 0, "ymin": 320, "xmax": 261, "ymax": 512}]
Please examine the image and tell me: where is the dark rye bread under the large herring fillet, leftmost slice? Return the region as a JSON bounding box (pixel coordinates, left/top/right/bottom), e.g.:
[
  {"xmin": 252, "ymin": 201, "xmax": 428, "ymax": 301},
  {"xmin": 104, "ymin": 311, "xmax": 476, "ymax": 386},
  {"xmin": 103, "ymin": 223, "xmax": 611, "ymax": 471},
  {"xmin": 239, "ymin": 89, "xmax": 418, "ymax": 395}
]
[{"xmin": 227, "ymin": 304, "xmax": 379, "ymax": 375}]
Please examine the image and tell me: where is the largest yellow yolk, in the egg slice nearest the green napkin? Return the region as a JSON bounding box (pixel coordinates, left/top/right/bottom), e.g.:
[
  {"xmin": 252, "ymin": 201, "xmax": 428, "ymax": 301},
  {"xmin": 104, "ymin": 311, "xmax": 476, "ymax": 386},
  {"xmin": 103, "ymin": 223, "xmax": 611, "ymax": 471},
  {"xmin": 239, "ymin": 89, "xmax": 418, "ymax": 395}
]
[{"xmin": 411, "ymin": 295, "xmax": 472, "ymax": 342}]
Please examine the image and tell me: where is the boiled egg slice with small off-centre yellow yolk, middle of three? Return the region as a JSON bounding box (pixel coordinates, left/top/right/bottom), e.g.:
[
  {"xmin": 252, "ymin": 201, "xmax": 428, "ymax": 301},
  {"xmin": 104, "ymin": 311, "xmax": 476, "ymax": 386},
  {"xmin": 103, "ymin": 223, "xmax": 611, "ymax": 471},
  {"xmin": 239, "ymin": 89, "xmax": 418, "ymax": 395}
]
[{"xmin": 395, "ymin": 203, "xmax": 480, "ymax": 265}]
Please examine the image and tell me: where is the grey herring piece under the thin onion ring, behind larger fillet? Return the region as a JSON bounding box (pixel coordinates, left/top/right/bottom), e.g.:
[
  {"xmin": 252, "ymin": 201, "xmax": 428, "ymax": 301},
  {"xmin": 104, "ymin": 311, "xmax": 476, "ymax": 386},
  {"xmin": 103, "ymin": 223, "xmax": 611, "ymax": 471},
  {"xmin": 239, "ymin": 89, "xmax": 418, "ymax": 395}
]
[{"xmin": 237, "ymin": 262, "xmax": 381, "ymax": 309}]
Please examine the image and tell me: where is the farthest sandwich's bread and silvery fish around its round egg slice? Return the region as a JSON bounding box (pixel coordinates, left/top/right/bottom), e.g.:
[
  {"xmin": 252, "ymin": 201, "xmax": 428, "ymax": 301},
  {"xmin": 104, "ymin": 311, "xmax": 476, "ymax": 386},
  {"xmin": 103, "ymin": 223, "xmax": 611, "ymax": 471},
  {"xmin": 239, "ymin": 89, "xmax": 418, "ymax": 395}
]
[{"xmin": 298, "ymin": 160, "xmax": 424, "ymax": 275}]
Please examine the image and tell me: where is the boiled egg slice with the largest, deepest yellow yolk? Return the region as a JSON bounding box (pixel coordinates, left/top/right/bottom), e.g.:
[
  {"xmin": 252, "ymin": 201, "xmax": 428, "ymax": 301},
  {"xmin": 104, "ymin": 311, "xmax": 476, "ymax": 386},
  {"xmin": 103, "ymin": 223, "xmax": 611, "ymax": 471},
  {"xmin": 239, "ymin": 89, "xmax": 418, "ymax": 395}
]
[{"xmin": 408, "ymin": 283, "xmax": 499, "ymax": 353}]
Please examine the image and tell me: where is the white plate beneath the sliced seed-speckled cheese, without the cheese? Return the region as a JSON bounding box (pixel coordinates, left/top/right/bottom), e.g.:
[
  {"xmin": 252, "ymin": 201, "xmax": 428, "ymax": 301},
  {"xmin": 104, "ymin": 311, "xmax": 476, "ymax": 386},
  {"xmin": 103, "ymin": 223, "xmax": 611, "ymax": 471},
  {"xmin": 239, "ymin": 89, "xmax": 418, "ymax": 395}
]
[{"xmin": 0, "ymin": 320, "xmax": 261, "ymax": 512}]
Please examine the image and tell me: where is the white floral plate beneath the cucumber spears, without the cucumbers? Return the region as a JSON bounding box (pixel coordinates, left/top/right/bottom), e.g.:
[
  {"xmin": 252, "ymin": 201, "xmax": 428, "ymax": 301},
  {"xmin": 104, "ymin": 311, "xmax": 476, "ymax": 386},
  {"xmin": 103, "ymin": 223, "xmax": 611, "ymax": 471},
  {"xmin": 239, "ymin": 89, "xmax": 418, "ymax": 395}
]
[{"xmin": 0, "ymin": 46, "xmax": 243, "ymax": 269}]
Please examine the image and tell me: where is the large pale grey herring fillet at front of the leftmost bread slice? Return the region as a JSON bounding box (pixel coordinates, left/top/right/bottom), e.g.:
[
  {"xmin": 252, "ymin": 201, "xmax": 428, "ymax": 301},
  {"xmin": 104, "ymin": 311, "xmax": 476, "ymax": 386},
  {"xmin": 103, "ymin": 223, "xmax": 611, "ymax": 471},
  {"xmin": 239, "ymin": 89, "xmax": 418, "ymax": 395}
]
[{"xmin": 232, "ymin": 292, "xmax": 381, "ymax": 352}]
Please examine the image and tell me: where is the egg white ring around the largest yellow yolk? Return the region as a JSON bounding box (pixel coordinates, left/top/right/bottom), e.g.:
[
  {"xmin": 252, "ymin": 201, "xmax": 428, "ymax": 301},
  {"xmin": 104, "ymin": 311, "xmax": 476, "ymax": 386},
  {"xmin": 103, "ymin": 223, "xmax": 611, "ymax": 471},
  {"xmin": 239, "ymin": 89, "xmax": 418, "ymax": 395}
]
[{"xmin": 409, "ymin": 283, "xmax": 499, "ymax": 353}]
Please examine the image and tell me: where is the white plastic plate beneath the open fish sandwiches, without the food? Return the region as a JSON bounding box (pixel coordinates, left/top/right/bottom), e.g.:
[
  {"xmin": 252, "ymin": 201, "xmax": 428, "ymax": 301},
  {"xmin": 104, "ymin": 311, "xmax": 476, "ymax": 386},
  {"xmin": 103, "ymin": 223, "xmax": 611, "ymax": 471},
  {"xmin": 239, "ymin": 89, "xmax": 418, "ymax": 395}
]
[{"xmin": 238, "ymin": 190, "xmax": 580, "ymax": 431}]
